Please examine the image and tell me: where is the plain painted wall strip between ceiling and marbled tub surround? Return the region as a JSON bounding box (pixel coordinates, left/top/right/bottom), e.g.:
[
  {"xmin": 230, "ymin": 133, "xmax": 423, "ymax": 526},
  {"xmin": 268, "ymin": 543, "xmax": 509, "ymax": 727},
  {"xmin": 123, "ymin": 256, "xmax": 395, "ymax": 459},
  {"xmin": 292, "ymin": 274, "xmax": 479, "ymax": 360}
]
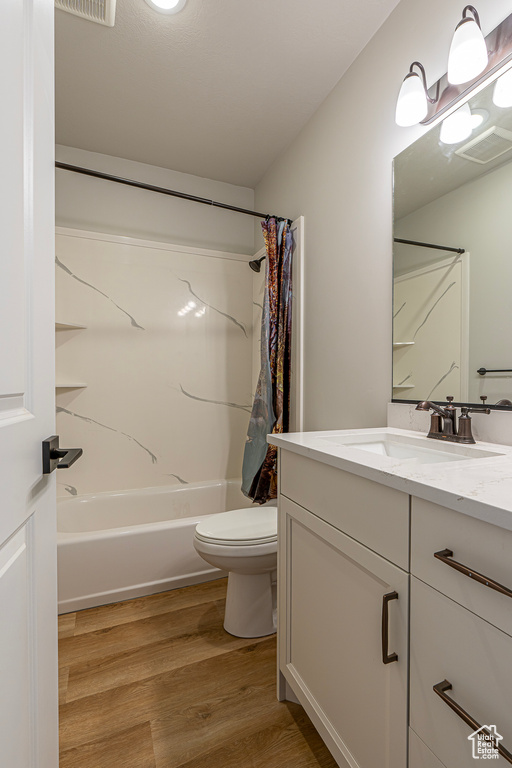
[{"xmin": 56, "ymin": 145, "xmax": 254, "ymax": 254}]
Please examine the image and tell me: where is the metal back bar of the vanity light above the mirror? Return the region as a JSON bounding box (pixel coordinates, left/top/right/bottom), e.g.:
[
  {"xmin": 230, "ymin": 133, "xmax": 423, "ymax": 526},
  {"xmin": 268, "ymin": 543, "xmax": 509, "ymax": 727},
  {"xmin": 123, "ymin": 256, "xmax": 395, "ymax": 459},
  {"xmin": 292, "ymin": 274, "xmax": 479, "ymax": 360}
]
[{"xmin": 421, "ymin": 9, "xmax": 512, "ymax": 125}]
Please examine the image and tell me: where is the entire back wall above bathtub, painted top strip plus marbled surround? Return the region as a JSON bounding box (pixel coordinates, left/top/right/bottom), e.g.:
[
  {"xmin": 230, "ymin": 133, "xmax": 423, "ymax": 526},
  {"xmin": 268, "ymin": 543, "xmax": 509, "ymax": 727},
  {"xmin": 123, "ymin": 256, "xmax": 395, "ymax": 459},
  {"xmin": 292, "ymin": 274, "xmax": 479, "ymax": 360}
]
[{"xmin": 56, "ymin": 146, "xmax": 254, "ymax": 496}]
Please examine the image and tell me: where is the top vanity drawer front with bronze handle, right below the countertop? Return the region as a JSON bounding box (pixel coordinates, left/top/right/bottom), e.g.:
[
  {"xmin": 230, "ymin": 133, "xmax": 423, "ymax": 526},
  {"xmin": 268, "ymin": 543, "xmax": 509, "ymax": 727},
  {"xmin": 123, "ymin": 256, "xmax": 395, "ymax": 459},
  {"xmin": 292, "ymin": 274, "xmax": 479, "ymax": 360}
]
[{"xmin": 411, "ymin": 498, "xmax": 512, "ymax": 635}]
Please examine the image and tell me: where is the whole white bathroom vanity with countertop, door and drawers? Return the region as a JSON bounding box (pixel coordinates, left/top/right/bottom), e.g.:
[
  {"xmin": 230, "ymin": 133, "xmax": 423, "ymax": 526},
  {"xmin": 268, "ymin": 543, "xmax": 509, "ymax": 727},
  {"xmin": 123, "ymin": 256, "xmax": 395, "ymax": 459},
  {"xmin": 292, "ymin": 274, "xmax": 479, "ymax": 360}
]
[{"xmin": 272, "ymin": 428, "xmax": 512, "ymax": 768}]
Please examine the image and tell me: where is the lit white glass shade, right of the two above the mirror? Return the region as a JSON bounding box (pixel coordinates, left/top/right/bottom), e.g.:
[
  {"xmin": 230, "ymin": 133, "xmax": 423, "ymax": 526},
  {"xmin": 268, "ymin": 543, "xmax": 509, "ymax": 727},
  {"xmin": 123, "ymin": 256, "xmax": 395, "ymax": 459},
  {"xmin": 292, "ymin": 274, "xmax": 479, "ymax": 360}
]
[{"xmin": 448, "ymin": 11, "xmax": 488, "ymax": 85}]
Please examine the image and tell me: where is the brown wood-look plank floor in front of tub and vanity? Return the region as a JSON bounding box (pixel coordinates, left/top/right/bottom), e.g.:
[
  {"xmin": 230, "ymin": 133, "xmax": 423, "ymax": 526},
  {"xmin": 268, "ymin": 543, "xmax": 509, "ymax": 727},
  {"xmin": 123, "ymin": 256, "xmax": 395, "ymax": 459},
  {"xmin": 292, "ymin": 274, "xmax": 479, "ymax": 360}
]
[{"xmin": 59, "ymin": 579, "xmax": 336, "ymax": 768}]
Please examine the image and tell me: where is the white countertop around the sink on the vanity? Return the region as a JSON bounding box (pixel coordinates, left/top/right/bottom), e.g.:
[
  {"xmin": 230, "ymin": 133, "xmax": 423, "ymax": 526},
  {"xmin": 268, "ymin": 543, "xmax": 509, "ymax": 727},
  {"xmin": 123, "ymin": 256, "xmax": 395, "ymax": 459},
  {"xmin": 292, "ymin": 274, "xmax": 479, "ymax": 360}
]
[{"xmin": 267, "ymin": 427, "xmax": 512, "ymax": 530}]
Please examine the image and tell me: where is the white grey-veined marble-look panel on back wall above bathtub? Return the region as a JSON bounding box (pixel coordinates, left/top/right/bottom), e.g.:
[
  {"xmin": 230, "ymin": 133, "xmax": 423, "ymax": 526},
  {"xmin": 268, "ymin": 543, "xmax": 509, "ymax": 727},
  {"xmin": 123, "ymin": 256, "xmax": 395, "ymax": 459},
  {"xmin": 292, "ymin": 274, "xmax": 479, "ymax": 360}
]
[{"xmin": 56, "ymin": 230, "xmax": 254, "ymax": 495}]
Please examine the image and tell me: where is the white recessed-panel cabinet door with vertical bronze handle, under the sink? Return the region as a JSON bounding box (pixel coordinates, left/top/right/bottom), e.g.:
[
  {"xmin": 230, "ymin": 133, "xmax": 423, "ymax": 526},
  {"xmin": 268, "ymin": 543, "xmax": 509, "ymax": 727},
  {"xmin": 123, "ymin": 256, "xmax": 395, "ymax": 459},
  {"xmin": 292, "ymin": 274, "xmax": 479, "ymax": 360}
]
[{"xmin": 279, "ymin": 497, "xmax": 408, "ymax": 768}]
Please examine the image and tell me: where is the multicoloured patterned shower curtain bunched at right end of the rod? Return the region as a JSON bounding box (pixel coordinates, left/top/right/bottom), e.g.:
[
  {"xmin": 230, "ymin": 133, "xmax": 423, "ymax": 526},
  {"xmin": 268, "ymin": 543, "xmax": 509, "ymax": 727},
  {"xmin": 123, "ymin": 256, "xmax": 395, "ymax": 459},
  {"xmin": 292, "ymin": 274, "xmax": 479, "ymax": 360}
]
[{"xmin": 242, "ymin": 217, "xmax": 293, "ymax": 504}]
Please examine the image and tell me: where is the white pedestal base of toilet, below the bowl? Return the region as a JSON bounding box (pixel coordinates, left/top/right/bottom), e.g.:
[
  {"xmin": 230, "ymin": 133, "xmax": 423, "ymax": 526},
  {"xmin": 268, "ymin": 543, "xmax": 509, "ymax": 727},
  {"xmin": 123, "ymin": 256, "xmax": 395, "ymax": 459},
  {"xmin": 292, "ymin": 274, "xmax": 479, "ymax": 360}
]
[{"xmin": 224, "ymin": 571, "xmax": 276, "ymax": 637}]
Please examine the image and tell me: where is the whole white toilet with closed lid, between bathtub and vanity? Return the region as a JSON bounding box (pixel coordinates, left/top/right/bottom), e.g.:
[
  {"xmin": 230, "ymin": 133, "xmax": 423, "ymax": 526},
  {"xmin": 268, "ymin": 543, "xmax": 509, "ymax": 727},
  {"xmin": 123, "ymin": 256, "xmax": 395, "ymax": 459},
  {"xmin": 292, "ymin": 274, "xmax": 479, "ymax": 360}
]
[{"xmin": 194, "ymin": 505, "xmax": 277, "ymax": 637}]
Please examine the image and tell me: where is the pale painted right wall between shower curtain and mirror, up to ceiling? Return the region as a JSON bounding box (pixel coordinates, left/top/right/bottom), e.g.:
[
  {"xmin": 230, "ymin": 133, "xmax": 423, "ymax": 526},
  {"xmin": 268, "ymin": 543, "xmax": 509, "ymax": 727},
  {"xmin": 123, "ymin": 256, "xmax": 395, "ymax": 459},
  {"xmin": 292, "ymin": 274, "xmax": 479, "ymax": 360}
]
[{"xmin": 255, "ymin": 0, "xmax": 511, "ymax": 429}]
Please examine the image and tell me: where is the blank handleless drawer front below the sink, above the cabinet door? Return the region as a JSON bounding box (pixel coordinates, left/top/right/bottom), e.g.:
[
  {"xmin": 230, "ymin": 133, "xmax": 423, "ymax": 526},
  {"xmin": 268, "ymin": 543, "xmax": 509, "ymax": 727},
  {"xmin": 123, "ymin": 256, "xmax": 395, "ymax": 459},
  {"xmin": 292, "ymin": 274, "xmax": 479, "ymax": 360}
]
[{"xmin": 279, "ymin": 449, "xmax": 409, "ymax": 570}]
